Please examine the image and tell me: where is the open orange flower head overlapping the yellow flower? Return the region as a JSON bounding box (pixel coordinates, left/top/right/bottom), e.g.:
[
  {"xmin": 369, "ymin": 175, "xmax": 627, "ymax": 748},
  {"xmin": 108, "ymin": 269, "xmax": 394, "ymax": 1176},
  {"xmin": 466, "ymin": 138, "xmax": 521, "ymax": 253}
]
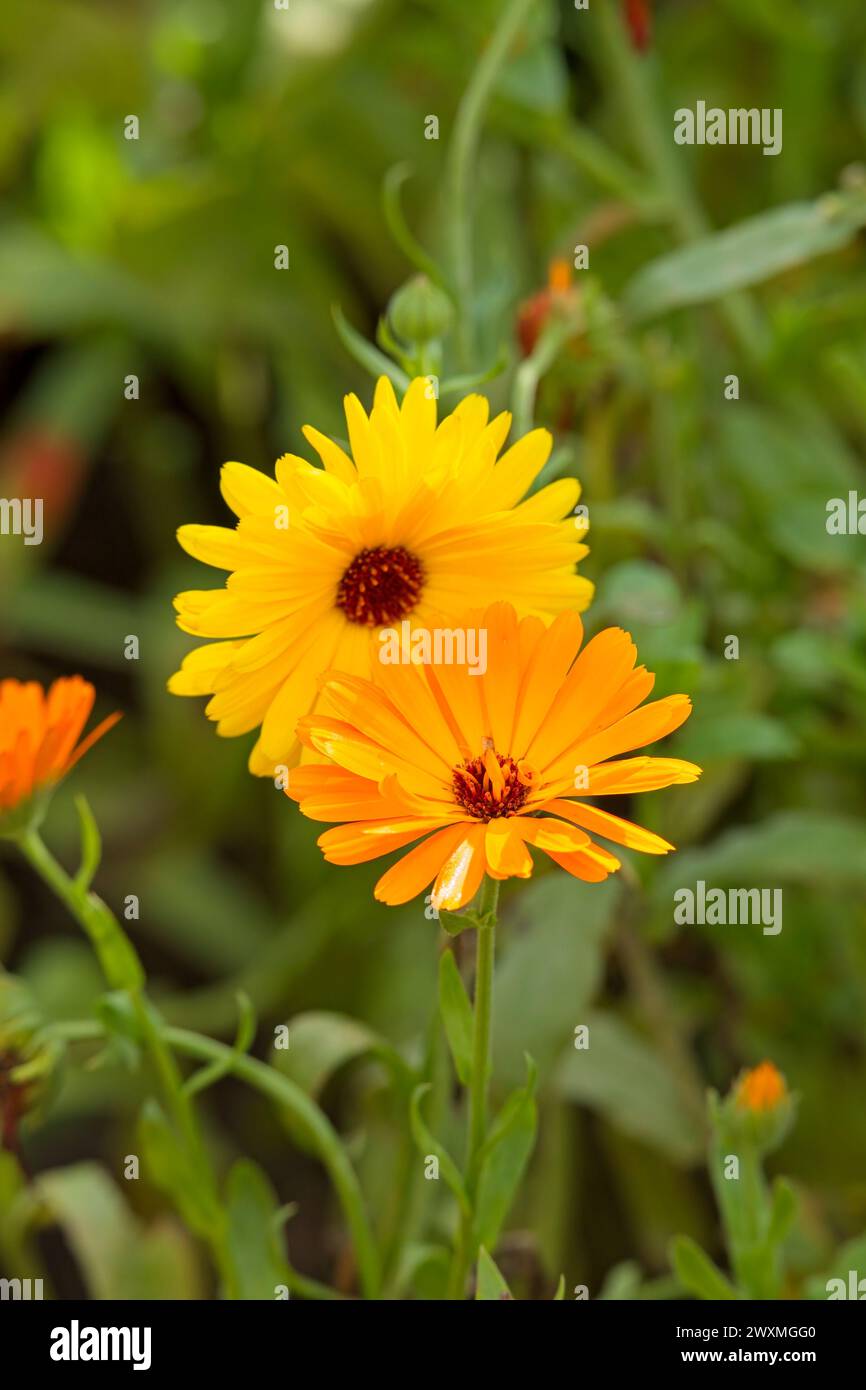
[{"xmin": 288, "ymin": 603, "xmax": 701, "ymax": 910}]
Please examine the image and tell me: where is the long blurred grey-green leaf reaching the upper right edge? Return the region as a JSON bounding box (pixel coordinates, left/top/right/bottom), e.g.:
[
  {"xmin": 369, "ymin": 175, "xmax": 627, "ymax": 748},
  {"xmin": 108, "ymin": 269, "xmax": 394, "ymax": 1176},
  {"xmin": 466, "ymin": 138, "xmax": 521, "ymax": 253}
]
[{"xmin": 621, "ymin": 192, "xmax": 866, "ymax": 320}]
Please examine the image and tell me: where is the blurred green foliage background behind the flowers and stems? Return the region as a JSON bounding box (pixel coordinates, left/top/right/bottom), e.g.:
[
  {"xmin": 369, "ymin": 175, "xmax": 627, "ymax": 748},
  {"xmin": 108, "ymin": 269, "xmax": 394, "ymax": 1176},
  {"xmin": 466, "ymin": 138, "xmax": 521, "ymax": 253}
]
[{"xmin": 0, "ymin": 0, "xmax": 866, "ymax": 1298}]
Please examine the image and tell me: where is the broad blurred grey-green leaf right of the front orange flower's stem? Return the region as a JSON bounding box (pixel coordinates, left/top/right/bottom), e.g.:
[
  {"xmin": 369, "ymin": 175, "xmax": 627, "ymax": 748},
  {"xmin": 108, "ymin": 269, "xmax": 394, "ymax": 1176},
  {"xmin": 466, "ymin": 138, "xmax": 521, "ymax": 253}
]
[{"xmin": 553, "ymin": 1013, "xmax": 702, "ymax": 1163}]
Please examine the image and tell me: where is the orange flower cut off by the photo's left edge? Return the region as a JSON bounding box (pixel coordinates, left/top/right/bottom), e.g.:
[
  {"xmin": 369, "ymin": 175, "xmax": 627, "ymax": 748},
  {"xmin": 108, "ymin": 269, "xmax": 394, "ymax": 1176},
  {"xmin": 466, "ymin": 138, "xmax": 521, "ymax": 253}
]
[{"xmin": 0, "ymin": 676, "xmax": 121, "ymax": 833}]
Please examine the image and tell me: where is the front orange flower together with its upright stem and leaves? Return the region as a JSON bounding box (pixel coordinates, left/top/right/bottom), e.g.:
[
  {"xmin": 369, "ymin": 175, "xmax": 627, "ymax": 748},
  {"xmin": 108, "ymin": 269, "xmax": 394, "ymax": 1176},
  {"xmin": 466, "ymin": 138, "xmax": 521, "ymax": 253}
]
[{"xmin": 288, "ymin": 603, "xmax": 699, "ymax": 1298}]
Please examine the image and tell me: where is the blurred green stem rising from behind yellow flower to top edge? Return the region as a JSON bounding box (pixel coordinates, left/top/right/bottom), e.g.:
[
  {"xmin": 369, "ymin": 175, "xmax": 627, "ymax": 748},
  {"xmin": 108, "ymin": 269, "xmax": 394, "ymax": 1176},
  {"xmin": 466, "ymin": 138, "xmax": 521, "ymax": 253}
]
[{"xmin": 449, "ymin": 0, "xmax": 535, "ymax": 368}]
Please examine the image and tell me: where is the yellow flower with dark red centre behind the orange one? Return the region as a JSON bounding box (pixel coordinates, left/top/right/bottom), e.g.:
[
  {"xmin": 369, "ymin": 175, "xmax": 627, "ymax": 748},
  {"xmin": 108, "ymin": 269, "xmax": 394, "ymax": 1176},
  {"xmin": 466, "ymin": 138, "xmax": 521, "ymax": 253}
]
[{"xmin": 168, "ymin": 377, "xmax": 592, "ymax": 776}]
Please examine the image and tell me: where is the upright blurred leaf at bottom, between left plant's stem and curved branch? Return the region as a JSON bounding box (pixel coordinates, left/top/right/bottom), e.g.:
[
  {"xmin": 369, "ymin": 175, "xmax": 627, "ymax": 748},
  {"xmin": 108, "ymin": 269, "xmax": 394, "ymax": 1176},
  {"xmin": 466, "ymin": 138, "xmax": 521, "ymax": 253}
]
[{"xmin": 225, "ymin": 1158, "xmax": 291, "ymax": 1300}]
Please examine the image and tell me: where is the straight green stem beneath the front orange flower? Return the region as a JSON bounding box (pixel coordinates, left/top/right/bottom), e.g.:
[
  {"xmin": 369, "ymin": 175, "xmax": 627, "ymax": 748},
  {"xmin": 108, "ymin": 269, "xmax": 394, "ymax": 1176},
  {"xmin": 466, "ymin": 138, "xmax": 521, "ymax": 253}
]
[{"xmin": 448, "ymin": 877, "xmax": 499, "ymax": 1300}]
